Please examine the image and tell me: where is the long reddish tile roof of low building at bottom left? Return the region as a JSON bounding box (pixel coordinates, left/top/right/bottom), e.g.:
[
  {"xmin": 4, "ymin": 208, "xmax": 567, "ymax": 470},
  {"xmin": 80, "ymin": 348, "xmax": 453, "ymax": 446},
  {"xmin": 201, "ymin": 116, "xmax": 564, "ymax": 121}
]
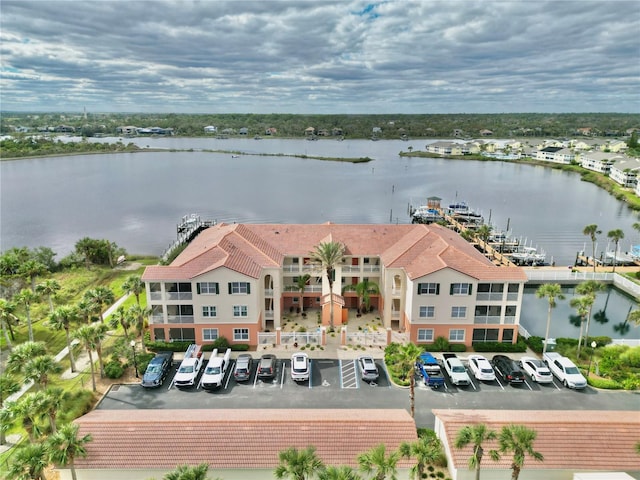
[{"xmin": 75, "ymin": 409, "xmax": 417, "ymax": 471}]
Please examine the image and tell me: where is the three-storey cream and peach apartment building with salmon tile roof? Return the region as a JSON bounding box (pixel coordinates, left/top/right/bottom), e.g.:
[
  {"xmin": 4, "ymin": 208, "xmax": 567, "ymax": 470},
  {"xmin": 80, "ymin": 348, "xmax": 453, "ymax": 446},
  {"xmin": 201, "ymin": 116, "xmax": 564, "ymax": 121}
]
[{"xmin": 142, "ymin": 223, "xmax": 527, "ymax": 345}]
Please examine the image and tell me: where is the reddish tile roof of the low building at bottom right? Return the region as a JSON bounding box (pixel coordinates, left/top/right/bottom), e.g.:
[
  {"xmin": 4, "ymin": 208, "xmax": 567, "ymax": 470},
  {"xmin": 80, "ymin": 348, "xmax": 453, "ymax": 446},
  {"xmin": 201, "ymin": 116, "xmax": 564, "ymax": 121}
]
[{"xmin": 433, "ymin": 410, "xmax": 640, "ymax": 471}]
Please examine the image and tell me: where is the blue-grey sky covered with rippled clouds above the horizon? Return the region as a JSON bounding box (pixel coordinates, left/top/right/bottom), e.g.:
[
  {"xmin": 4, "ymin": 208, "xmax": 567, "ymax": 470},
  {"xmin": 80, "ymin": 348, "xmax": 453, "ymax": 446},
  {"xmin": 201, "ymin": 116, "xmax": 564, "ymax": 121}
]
[{"xmin": 0, "ymin": 0, "xmax": 640, "ymax": 113}]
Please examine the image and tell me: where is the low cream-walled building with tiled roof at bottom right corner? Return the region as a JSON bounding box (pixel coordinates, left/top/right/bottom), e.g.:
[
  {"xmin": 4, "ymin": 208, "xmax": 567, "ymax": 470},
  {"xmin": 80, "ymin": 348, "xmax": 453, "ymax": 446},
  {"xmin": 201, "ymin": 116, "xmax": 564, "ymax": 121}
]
[{"xmin": 432, "ymin": 409, "xmax": 640, "ymax": 480}]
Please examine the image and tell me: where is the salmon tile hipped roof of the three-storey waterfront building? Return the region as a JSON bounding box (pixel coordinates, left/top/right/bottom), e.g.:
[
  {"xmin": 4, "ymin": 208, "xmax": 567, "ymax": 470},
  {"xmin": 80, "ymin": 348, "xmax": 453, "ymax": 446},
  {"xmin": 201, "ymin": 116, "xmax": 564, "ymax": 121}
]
[{"xmin": 142, "ymin": 223, "xmax": 526, "ymax": 281}]
